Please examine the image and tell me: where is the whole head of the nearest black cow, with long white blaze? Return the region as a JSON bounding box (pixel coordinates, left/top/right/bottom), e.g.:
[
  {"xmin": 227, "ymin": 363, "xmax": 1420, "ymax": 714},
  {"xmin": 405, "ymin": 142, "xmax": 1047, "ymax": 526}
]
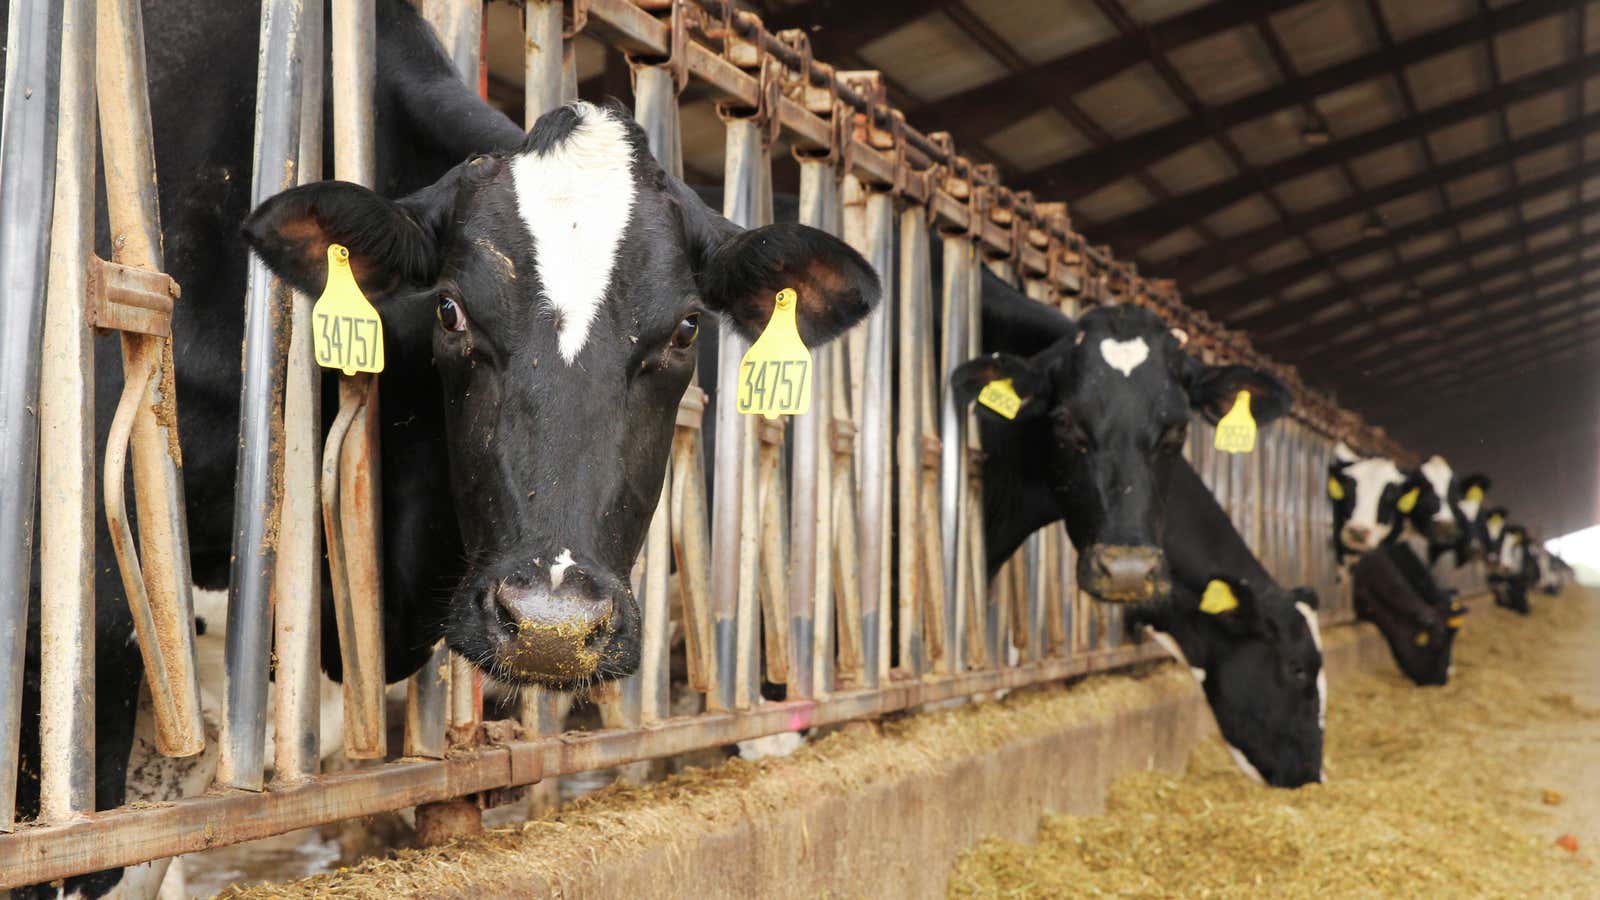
[{"xmin": 245, "ymin": 102, "xmax": 878, "ymax": 689}]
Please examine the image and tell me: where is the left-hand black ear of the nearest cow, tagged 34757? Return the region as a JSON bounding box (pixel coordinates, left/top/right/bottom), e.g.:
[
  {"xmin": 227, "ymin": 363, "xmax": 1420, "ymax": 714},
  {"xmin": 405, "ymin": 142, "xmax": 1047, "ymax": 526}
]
[{"xmin": 243, "ymin": 181, "xmax": 442, "ymax": 298}]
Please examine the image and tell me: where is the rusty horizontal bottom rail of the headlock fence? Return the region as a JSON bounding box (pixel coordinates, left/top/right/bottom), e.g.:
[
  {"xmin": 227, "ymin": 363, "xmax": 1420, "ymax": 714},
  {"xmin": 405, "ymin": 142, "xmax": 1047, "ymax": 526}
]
[{"xmin": 0, "ymin": 644, "xmax": 1165, "ymax": 889}]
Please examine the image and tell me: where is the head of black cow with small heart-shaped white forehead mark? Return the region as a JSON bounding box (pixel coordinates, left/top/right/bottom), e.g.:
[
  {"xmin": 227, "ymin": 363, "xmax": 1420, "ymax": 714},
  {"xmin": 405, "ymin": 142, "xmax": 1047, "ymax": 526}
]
[{"xmin": 950, "ymin": 306, "xmax": 1290, "ymax": 602}]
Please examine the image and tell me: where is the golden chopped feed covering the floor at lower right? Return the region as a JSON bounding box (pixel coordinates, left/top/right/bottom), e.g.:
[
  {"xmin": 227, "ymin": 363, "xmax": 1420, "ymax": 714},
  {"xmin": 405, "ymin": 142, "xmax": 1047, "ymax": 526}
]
[{"xmin": 950, "ymin": 589, "xmax": 1600, "ymax": 897}]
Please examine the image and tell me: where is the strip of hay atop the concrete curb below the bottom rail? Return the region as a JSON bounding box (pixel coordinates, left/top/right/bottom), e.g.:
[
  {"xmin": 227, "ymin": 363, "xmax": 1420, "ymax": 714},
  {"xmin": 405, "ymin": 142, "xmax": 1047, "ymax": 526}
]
[{"xmin": 222, "ymin": 663, "xmax": 1194, "ymax": 900}]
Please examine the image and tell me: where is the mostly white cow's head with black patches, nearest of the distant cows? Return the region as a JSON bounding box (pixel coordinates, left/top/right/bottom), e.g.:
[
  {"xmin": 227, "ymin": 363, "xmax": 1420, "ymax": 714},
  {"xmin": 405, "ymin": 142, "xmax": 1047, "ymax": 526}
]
[{"xmin": 1328, "ymin": 442, "xmax": 1432, "ymax": 557}]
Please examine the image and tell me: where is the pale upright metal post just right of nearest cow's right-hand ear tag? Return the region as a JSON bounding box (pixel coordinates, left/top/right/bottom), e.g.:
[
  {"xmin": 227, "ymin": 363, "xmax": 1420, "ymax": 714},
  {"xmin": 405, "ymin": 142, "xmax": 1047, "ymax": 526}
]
[{"xmin": 789, "ymin": 157, "xmax": 850, "ymax": 698}]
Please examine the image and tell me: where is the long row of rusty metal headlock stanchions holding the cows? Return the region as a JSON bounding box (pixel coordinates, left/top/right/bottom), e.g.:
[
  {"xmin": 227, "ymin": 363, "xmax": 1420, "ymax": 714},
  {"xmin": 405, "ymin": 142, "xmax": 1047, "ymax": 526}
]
[{"xmin": 0, "ymin": 0, "xmax": 1414, "ymax": 889}]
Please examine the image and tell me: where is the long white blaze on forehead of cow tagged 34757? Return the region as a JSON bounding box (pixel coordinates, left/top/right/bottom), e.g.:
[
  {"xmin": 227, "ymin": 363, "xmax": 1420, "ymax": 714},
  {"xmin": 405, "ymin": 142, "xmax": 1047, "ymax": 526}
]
[{"xmin": 510, "ymin": 101, "xmax": 634, "ymax": 358}]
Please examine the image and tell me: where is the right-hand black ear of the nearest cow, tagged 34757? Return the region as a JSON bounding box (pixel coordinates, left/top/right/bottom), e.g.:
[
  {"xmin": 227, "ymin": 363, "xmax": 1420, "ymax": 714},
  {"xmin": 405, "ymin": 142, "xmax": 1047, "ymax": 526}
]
[{"xmin": 669, "ymin": 178, "xmax": 882, "ymax": 346}]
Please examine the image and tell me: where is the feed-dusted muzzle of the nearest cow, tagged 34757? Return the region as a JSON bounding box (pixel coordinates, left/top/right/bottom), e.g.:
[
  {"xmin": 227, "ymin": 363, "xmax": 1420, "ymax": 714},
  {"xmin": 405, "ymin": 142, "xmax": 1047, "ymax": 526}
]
[{"xmin": 448, "ymin": 554, "xmax": 642, "ymax": 692}]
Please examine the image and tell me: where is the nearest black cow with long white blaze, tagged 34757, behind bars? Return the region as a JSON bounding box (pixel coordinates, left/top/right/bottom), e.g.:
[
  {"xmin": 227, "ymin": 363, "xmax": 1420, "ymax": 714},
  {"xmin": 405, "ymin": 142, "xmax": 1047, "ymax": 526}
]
[{"xmin": 0, "ymin": 0, "xmax": 878, "ymax": 895}]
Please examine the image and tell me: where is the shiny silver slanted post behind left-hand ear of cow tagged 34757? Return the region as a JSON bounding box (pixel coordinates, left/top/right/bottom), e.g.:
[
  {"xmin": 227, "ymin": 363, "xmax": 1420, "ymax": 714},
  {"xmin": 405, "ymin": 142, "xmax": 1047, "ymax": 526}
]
[{"xmin": 216, "ymin": 0, "xmax": 301, "ymax": 791}]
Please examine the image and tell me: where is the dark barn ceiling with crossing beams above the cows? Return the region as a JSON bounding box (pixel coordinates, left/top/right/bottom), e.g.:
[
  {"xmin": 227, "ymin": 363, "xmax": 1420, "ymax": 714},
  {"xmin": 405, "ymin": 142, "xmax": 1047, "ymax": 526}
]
[{"xmin": 476, "ymin": 0, "xmax": 1600, "ymax": 530}]
